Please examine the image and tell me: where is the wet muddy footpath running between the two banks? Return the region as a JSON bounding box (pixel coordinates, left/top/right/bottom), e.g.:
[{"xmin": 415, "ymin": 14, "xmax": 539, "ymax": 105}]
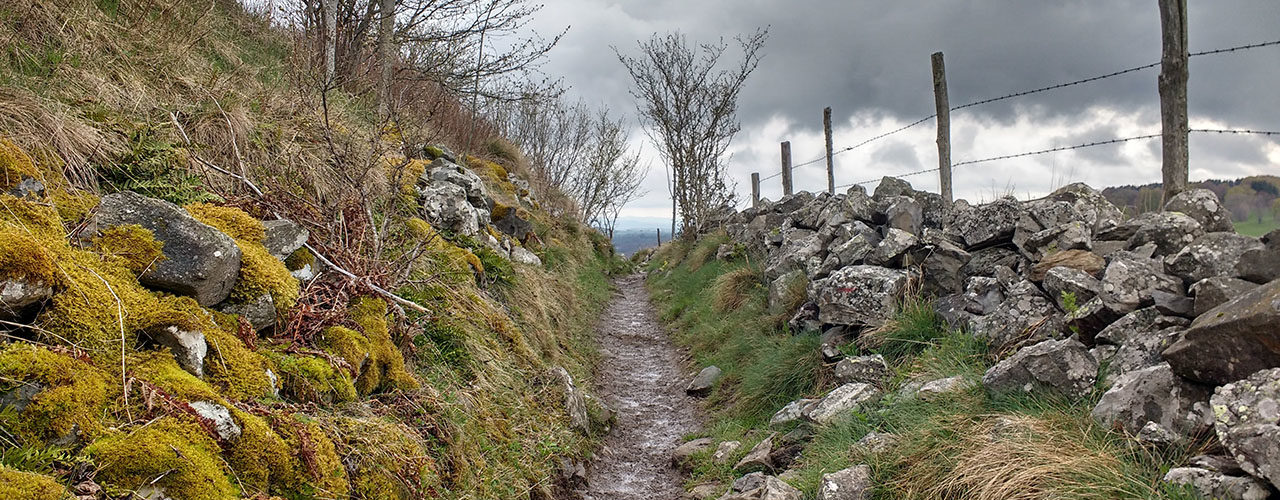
[{"xmin": 581, "ymin": 275, "xmax": 699, "ymax": 500}]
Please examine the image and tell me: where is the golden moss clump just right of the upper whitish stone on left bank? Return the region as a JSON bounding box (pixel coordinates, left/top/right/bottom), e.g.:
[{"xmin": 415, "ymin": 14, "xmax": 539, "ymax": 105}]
[{"xmin": 205, "ymin": 327, "xmax": 271, "ymax": 399}]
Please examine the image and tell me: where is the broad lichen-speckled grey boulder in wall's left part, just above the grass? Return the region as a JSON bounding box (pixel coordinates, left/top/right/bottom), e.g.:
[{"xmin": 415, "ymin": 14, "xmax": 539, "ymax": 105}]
[{"xmin": 809, "ymin": 266, "xmax": 908, "ymax": 326}]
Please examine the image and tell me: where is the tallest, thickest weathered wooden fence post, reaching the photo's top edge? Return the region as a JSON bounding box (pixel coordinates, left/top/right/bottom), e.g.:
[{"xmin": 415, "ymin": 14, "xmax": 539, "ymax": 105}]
[{"xmin": 1157, "ymin": 0, "xmax": 1188, "ymax": 205}]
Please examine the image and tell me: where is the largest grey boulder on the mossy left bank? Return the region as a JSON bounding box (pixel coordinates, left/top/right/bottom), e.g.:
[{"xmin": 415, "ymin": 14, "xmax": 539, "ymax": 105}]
[{"xmin": 81, "ymin": 191, "xmax": 241, "ymax": 307}]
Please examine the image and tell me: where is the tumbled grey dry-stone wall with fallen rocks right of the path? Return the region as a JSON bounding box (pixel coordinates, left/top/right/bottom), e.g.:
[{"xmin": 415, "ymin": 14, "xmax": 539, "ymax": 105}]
[{"xmin": 700, "ymin": 178, "xmax": 1280, "ymax": 500}]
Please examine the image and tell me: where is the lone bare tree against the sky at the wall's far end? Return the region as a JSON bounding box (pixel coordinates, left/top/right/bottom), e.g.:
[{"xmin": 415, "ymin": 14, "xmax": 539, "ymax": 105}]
[{"xmin": 614, "ymin": 28, "xmax": 768, "ymax": 235}]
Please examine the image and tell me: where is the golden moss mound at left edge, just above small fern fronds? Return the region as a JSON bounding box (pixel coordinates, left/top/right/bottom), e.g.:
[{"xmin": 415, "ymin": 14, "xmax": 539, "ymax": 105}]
[{"xmin": 0, "ymin": 343, "xmax": 112, "ymax": 442}]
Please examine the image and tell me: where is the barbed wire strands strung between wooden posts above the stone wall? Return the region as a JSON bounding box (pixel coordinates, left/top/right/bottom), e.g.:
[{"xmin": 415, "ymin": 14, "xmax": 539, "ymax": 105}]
[{"xmin": 751, "ymin": 33, "xmax": 1280, "ymax": 206}]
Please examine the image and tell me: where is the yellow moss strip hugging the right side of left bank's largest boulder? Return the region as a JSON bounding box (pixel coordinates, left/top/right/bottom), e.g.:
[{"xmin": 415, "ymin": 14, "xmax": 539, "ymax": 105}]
[{"xmin": 186, "ymin": 203, "xmax": 300, "ymax": 315}]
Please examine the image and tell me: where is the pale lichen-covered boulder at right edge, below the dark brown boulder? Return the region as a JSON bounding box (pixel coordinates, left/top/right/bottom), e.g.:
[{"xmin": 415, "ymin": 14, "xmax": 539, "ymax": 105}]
[{"xmin": 1210, "ymin": 368, "xmax": 1280, "ymax": 487}]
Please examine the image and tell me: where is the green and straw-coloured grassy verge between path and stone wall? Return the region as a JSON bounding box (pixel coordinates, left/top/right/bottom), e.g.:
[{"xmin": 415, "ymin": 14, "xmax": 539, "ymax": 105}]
[{"xmin": 649, "ymin": 235, "xmax": 1198, "ymax": 499}]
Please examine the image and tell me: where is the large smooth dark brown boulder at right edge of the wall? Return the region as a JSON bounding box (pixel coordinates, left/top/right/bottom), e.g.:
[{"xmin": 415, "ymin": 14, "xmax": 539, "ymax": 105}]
[{"xmin": 1165, "ymin": 280, "xmax": 1280, "ymax": 385}]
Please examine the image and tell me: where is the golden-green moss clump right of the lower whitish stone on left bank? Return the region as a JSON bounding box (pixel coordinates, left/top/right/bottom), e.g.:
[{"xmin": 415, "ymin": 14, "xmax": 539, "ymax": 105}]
[{"xmin": 225, "ymin": 408, "xmax": 298, "ymax": 496}]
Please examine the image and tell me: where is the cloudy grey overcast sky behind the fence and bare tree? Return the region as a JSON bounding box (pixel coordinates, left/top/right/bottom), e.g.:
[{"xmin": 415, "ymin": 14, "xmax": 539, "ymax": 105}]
[{"xmin": 531, "ymin": 0, "xmax": 1280, "ymax": 227}]
